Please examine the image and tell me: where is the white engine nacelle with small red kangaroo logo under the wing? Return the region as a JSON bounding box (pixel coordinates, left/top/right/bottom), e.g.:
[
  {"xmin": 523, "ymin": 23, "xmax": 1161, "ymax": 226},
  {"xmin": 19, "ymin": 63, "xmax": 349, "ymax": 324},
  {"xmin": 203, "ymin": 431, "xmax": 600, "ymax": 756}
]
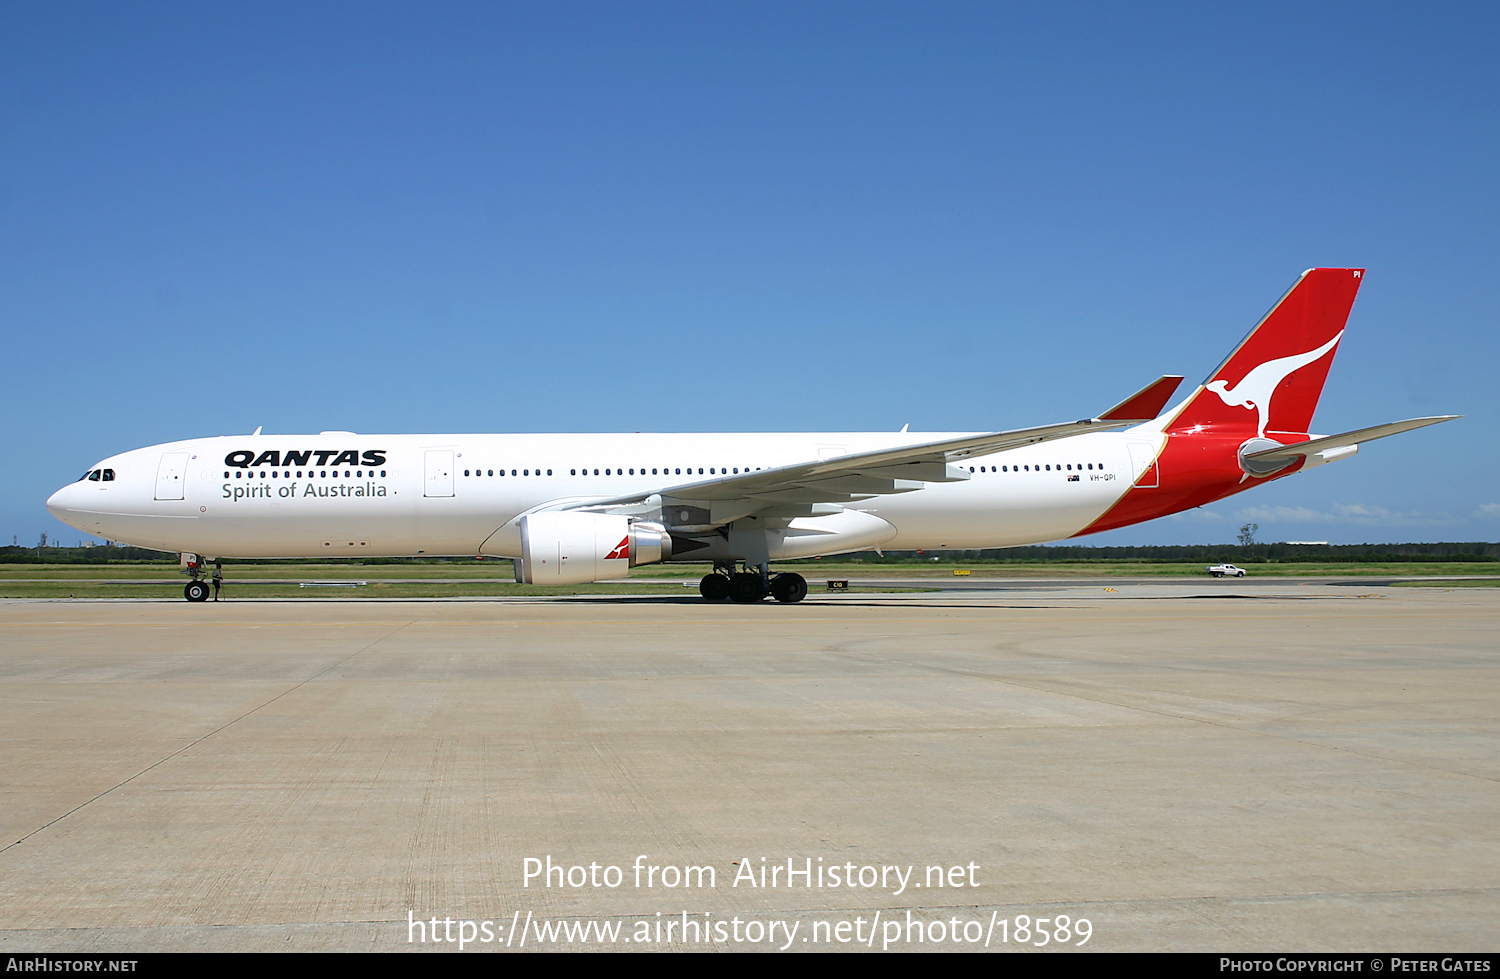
[{"xmin": 516, "ymin": 511, "xmax": 672, "ymax": 585}]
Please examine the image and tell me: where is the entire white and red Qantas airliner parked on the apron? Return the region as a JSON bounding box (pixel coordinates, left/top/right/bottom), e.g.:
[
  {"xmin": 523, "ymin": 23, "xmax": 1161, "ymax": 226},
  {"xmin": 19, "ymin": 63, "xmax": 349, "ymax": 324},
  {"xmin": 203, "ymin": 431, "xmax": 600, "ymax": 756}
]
[{"xmin": 47, "ymin": 268, "xmax": 1457, "ymax": 601}]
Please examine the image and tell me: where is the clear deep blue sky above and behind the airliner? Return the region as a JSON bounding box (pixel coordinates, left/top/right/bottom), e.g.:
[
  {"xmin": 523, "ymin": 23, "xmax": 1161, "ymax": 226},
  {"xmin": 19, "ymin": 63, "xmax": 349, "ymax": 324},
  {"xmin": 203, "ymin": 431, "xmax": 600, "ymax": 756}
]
[{"xmin": 0, "ymin": 3, "xmax": 1500, "ymax": 543}]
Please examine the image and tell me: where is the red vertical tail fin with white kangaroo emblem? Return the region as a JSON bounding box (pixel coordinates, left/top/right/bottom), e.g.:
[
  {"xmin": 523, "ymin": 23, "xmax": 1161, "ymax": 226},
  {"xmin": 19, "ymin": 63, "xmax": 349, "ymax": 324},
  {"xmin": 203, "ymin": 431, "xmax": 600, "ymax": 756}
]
[{"xmin": 1167, "ymin": 268, "xmax": 1365, "ymax": 438}]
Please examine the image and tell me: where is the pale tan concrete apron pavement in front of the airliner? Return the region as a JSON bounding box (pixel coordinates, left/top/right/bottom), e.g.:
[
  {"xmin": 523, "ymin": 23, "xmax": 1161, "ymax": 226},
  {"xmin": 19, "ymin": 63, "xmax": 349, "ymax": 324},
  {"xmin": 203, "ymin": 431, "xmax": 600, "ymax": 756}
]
[{"xmin": 0, "ymin": 579, "xmax": 1500, "ymax": 952}]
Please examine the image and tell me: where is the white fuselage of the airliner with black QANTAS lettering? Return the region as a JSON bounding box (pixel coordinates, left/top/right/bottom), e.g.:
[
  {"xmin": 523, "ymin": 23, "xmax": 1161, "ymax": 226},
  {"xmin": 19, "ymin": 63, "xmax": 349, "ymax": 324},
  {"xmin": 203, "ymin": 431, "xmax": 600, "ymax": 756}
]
[{"xmin": 48, "ymin": 430, "xmax": 1163, "ymax": 561}]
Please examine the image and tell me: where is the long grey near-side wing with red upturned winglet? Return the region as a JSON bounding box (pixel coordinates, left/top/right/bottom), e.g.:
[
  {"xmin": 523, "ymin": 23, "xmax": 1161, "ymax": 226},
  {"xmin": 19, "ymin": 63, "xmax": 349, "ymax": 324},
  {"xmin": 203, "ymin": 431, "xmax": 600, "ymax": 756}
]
[{"xmin": 572, "ymin": 376, "xmax": 1182, "ymax": 515}]
